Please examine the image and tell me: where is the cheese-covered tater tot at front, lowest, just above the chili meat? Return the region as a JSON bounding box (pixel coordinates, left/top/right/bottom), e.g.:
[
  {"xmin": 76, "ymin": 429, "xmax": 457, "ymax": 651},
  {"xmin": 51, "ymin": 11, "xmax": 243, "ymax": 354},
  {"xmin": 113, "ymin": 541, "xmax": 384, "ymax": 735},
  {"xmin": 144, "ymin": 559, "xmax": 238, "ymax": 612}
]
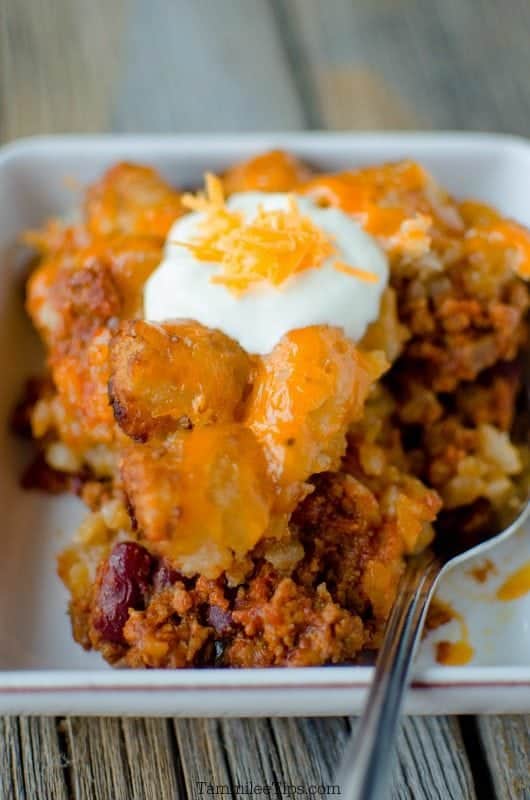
[{"xmin": 121, "ymin": 425, "xmax": 274, "ymax": 577}]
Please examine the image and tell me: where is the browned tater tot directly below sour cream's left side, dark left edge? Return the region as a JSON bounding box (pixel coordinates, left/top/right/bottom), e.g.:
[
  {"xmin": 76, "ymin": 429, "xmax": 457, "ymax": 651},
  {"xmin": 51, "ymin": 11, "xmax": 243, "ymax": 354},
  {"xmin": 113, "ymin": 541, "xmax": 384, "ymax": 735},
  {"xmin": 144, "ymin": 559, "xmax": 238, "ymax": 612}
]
[{"xmin": 110, "ymin": 320, "xmax": 251, "ymax": 440}]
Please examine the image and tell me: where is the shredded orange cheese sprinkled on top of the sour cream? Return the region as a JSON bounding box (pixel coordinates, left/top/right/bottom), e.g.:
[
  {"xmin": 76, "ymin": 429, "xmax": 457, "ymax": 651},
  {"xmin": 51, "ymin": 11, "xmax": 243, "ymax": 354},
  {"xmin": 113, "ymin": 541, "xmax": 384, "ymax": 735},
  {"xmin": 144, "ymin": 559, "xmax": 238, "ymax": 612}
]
[{"xmin": 175, "ymin": 173, "xmax": 378, "ymax": 293}]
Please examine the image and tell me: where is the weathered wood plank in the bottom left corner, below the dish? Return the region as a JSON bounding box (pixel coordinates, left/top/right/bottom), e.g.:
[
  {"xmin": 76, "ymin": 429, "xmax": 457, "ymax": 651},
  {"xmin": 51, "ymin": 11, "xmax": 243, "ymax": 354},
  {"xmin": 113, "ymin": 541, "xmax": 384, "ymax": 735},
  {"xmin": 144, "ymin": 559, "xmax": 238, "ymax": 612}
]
[{"xmin": 0, "ymin": 717, "xmax": 68, "ymax": 800}]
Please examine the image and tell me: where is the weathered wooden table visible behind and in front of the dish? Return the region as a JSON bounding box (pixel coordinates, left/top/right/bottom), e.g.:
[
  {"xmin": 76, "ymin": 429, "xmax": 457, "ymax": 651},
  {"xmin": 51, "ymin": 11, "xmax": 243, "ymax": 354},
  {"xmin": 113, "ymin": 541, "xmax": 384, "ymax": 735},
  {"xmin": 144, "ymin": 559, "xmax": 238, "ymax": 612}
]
[{"xmin": 0, "ymin": 0, "xmax": 530, "ymax": 800}]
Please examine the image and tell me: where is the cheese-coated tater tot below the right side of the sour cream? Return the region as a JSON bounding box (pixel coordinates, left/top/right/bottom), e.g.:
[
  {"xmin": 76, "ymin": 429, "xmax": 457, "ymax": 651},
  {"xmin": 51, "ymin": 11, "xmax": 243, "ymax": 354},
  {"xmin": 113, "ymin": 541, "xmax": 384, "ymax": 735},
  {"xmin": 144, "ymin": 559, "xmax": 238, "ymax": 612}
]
[{"xmin": 245, "ymin": 325, "xmax": 383, "ymax": 504}]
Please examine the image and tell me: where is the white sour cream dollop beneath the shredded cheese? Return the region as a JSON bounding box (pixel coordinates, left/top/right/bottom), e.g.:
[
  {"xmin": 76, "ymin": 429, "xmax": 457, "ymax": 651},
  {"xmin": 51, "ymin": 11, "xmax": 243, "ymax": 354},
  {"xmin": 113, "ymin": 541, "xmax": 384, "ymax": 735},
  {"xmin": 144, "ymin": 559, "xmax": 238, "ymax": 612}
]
[{"xmin": 144, "ymin": 192, "xmax": 388, "ymax": 355}]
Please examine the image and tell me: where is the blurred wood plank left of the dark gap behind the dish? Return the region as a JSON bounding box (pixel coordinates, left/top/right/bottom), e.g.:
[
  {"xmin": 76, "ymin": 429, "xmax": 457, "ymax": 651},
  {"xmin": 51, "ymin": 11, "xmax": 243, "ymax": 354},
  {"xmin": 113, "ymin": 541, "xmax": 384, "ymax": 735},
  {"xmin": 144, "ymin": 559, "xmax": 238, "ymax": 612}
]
[{"xmin": 0, "ymin": 0, "xmax": 305, "ymax": 141}]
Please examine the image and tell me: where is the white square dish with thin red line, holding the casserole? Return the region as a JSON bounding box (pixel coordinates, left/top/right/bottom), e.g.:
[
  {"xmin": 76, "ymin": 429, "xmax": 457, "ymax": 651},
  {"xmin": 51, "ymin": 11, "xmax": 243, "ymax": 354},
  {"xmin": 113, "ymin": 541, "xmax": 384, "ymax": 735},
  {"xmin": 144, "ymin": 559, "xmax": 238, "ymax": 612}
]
[{"xmin": 0, "ymin": 133, "xmax": 530, "ymax": 716}]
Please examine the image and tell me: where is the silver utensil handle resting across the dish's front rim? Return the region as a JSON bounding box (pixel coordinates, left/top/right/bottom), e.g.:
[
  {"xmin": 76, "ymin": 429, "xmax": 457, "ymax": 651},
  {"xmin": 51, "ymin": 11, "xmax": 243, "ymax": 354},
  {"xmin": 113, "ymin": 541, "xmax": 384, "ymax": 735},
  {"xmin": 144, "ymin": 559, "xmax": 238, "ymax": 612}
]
[{"xmin": 335, "ymin": 554, "xmax": 442, "ymax": 800}]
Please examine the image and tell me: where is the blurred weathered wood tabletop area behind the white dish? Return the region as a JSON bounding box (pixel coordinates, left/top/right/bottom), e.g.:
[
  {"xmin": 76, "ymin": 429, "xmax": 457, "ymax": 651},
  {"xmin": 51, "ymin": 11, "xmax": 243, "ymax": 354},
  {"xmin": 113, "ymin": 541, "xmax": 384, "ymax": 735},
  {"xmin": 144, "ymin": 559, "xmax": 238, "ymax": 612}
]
[{"xmin": 6, "ymin": 0, "xmax": 530, "ymax": 140}]
